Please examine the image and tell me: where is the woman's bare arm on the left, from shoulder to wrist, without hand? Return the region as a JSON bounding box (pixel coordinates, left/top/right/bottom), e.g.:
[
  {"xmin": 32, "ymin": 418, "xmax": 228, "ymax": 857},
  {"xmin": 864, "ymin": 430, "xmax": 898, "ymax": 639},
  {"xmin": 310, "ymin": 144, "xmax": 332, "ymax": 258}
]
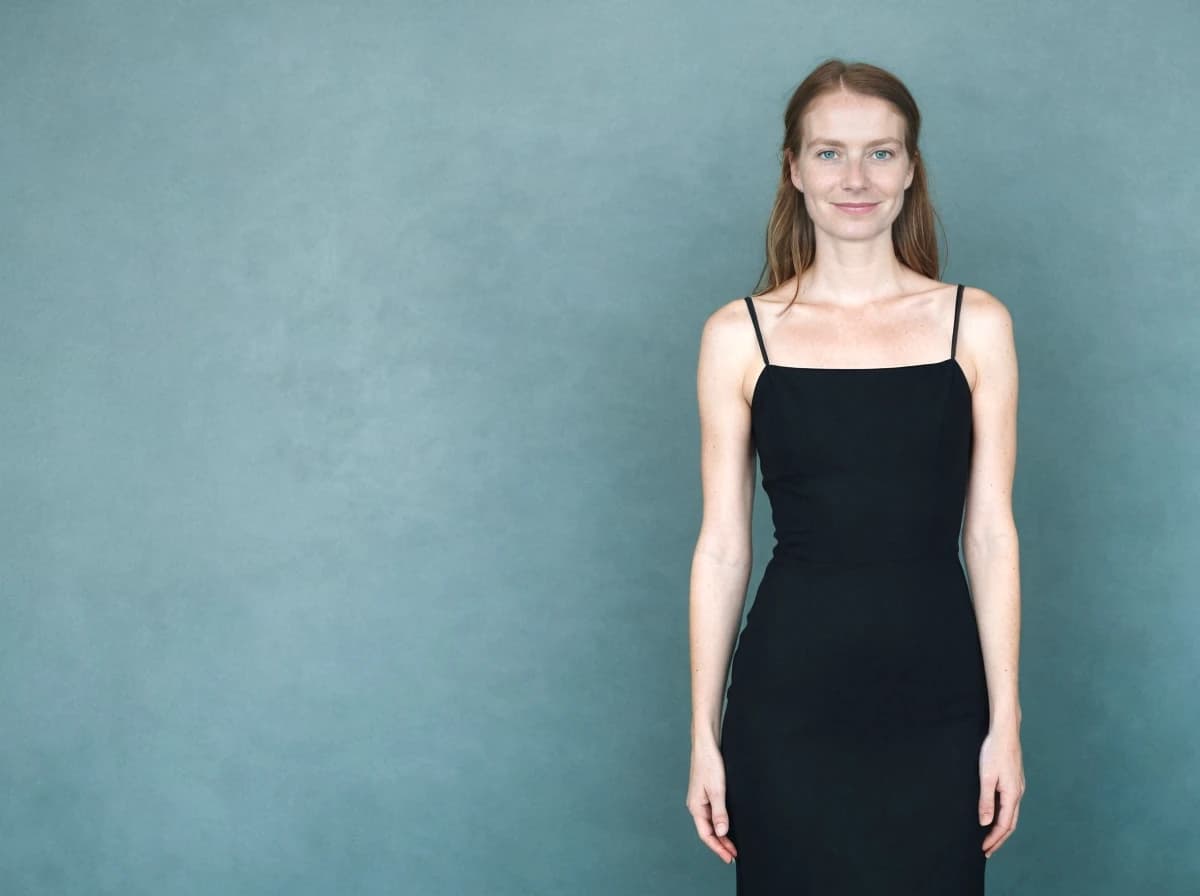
[{"xmin": 689, "ymin": 300, "xmax": 755, "ymax": 750}]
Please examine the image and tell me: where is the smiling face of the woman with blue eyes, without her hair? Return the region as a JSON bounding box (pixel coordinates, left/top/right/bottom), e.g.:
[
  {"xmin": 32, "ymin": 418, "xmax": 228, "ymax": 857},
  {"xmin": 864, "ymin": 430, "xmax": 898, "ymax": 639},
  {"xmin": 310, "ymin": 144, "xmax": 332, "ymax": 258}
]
[{"xmin": 791, "ymin": 92, "xmax": 914, "ymax": 240}]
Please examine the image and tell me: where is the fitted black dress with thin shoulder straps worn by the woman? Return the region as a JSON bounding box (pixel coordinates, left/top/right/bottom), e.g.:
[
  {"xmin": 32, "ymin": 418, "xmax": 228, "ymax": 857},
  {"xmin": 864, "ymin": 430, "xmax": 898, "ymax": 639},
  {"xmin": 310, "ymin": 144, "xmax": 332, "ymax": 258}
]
[{"xmin": 721, "ymin": 284, "xmax": 995, "ymax": 896}]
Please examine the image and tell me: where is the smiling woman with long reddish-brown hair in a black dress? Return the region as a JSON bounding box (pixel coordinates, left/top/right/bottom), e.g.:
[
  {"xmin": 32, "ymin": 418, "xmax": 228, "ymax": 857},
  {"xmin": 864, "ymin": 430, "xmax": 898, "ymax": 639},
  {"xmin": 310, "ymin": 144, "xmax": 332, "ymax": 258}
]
[{"xmin": 686, "ymin": 60, "xmax": 1025, "ymax": 896}]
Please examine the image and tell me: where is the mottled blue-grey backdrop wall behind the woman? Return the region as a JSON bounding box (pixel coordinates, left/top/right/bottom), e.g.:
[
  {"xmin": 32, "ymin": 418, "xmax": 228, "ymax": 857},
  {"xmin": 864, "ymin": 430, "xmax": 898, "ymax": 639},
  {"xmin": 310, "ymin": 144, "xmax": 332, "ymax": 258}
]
[{"xmin": 0, "ymin": 0, "xmax": 1200, "ymax": 896}]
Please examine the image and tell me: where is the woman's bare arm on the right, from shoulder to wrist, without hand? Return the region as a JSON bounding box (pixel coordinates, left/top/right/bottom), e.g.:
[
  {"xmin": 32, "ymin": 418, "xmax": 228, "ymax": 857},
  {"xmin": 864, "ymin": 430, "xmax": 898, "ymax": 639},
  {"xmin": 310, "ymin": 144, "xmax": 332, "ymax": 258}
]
[{"xmin": 962, "ymin": 290, "xmax": 1021, "ymax": 730}]
